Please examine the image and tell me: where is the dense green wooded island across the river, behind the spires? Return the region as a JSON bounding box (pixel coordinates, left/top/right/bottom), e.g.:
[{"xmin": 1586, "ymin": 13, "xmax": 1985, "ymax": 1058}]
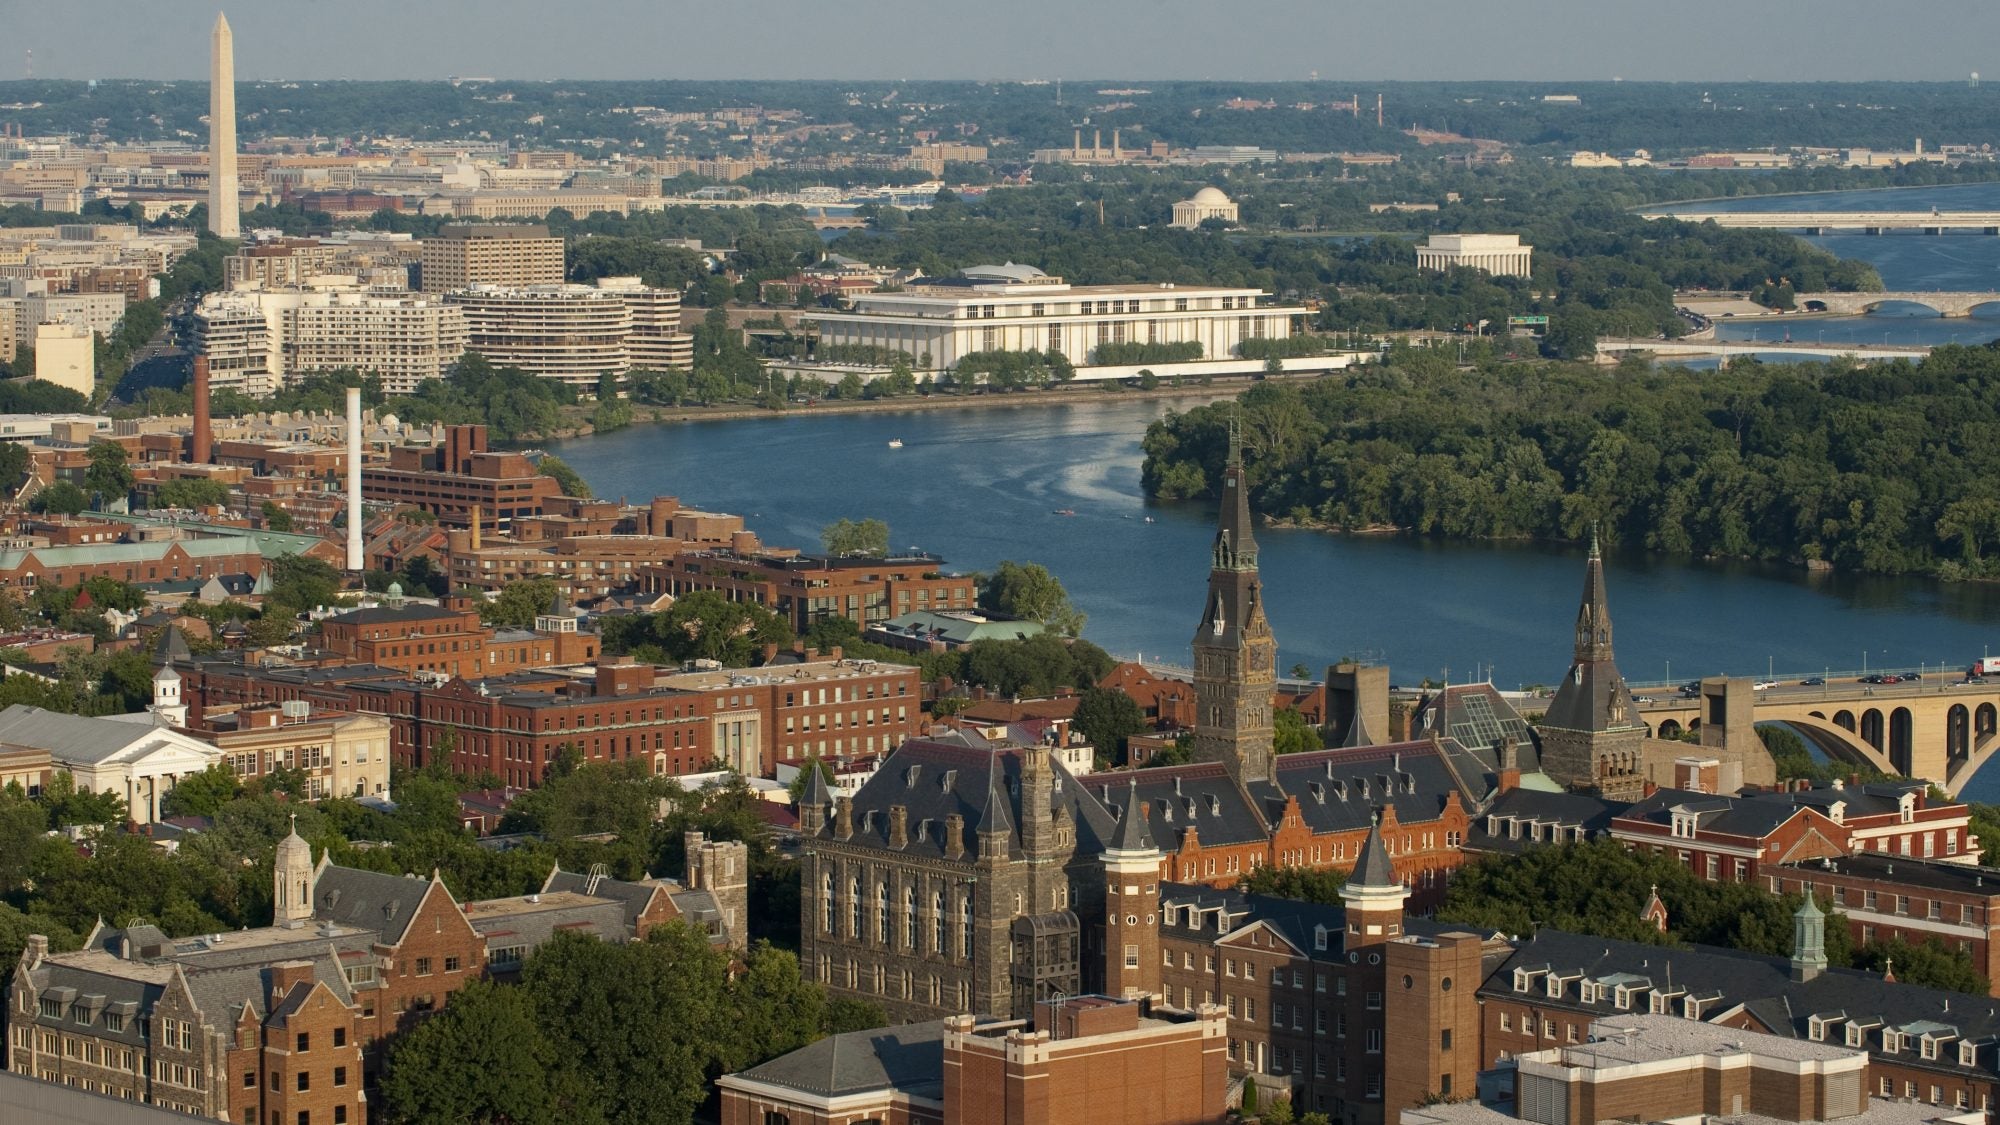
[{"xmin": 1144, "ymin": 344, "xmax": 2000, "ymax": 579}]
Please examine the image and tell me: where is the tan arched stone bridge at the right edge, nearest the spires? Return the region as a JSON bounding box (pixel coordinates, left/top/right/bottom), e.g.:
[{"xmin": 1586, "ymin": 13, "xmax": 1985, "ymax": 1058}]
[{"xmin": 1640, "ymin": 679, "xmax": 2000, "ymax": 797}]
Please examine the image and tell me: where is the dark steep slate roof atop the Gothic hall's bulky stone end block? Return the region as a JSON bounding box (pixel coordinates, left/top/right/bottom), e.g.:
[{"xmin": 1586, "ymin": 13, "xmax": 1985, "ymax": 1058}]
[{"xmin": 828, "ymin": 733, "xmax": 1116, "ymax": 857}]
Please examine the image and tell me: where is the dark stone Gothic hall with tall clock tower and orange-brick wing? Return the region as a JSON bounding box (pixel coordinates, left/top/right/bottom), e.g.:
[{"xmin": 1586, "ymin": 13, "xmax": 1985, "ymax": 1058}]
[{"xmin": 800, "ymin": 424, "xmax": 1484, "ymax": 1020}]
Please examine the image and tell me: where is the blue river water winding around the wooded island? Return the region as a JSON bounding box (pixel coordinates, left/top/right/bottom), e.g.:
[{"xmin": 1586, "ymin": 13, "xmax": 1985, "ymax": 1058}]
[{"xmin": 552, "ymin": 177, "xmax": 2000, "ymax": 799}]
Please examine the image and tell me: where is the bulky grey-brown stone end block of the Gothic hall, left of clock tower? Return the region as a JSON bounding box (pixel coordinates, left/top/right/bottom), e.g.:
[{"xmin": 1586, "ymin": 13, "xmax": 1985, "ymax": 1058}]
[{"xmin": 798, "ymin": 735, "xmax": 1114, "ymax": 1021}]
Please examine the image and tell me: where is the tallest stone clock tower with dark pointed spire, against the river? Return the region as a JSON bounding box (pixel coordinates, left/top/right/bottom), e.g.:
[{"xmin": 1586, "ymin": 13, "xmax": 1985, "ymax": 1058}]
[{"xmin": 1194, "ymin": 406, "xmax": 1278, "ymax": 785}]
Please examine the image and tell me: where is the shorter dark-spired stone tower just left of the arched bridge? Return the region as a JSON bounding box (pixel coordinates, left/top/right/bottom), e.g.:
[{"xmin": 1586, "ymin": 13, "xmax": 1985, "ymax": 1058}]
[{"xmin": 1536, "ymin": 530, "xmax": 1646, "ymax": 801}]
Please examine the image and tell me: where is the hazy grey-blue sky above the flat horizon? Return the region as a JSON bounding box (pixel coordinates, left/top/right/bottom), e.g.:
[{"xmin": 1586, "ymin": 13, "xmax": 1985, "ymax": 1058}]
[{"xmin": 15, "ymin": 0, "xmax": 2000, "ymax": 82}]
